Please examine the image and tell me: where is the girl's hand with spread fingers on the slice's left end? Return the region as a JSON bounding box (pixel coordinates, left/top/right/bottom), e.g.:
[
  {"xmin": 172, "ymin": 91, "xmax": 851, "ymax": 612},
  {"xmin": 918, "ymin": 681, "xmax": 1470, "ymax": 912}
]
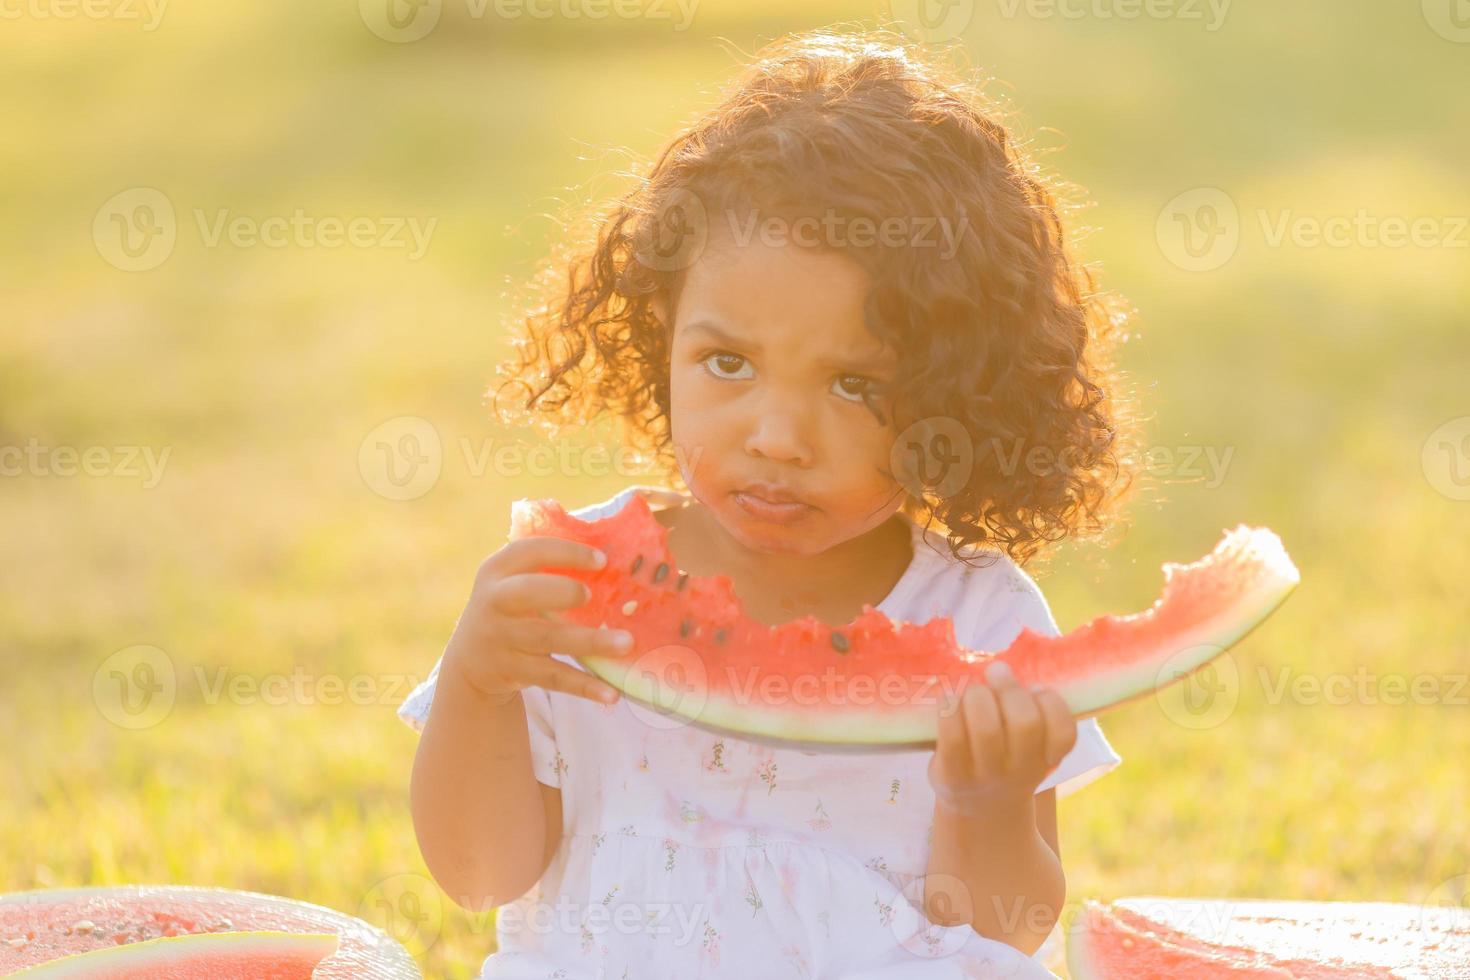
[{"xmin": 441, "ymin": 535, "xmax": 632, "ymax": 704}]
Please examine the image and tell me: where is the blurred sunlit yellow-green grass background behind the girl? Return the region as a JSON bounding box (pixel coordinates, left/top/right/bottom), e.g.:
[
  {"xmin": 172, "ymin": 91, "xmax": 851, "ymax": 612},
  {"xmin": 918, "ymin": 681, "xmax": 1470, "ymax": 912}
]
[{"xmin": 0, "ymin": 0, "xmax": 1470, "ymax": 977}]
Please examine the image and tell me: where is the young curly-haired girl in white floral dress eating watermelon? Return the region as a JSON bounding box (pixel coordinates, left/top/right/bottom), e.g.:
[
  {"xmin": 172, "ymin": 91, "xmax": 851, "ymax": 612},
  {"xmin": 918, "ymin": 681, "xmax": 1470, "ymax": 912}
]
[{"xmin": 400, "ymin": 32, "xmax": 1129, "ymax": 980}]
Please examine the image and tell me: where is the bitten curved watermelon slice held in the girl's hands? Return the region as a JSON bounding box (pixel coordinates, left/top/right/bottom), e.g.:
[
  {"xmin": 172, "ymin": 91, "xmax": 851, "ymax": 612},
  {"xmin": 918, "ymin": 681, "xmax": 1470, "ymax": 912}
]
[{"xmin": 510, "ymin": 494, "xmax": 1299, "ymax": 751}]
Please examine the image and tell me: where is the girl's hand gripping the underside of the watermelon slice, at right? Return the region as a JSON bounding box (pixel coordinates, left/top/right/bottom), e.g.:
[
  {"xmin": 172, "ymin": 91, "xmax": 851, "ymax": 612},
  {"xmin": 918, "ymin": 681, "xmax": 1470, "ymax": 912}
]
[{"xmin": 929, "ymin": 661, "xmax": 1078, "ymax": 815}]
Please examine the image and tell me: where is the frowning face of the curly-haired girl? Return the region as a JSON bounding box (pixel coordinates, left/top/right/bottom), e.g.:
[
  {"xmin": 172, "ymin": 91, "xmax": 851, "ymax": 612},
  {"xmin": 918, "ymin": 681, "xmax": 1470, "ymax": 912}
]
[{"xmin": 666, "ymin": 224, "xmax": 904, "ymax": 555}]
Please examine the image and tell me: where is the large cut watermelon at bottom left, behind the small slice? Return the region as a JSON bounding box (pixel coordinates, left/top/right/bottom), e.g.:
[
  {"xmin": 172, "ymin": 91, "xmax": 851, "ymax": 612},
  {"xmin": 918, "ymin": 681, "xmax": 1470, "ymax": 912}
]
[{"xmin": 0, "ymin": 884, "xmax": 422, "ymax": 980}]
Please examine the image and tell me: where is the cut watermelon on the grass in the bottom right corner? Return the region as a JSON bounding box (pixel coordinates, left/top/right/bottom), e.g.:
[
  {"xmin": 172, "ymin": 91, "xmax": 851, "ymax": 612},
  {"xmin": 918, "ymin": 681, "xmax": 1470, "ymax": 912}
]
[{"xmin": 1067, "ymin": 898, "xmax": 1470, "ymax": 980}]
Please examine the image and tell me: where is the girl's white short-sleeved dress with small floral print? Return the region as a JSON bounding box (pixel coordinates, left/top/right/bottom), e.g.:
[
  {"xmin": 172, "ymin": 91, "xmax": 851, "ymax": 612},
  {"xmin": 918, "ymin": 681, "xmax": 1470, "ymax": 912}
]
[{"xmin": 398, "ymin": 486, "xmax": 1122, "ymax": 980}]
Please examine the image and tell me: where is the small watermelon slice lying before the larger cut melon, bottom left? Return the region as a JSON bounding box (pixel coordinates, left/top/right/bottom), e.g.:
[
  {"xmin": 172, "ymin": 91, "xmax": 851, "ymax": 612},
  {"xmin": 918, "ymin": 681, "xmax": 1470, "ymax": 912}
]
[{"xmin": 10, "ymin": 932, "xmax": 337, "ymax": 980}]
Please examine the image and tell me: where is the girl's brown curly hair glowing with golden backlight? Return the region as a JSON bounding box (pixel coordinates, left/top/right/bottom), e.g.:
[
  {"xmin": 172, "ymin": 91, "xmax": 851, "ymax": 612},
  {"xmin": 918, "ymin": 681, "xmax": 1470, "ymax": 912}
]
[{"xmin": 490, "ymin": 29, "xmax": 1136, "ymax": 564}]
